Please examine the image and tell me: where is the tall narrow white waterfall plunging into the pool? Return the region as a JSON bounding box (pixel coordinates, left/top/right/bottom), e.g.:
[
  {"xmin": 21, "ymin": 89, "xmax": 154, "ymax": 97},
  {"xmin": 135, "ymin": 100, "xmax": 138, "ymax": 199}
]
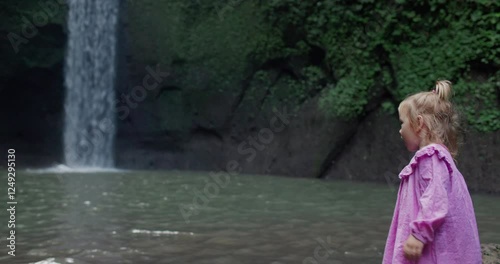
[{"xmin": 64, "ymin": 0, "xmax": 120, "ymax": 168}]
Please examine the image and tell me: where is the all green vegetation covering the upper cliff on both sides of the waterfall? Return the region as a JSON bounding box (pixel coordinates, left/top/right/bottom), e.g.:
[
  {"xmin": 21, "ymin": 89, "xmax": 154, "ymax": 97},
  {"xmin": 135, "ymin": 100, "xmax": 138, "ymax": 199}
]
[{"xmin": 0, "ymin": 0, "xmax": 500, "ymax": 132}]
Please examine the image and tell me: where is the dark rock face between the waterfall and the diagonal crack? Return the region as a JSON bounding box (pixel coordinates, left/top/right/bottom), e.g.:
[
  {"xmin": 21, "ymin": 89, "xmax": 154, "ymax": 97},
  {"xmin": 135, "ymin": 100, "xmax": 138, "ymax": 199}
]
[{"xmin": 117, "ymin": 95, "xmax": 357, "ymax": 178}]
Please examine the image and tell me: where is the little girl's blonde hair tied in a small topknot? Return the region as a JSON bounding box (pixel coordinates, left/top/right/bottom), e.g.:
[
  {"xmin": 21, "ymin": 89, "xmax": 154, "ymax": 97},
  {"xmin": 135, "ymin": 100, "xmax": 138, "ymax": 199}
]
[{"xmin": 400, "ymin": 80, "xmax": 460, "ymax": 158}]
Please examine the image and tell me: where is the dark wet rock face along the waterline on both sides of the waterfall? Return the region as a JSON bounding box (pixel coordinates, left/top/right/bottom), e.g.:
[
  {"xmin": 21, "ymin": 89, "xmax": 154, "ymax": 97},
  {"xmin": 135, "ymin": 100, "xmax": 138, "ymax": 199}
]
[{"xmin": 4, "ymin": 71, "xmax": 500, "ymax": 193}]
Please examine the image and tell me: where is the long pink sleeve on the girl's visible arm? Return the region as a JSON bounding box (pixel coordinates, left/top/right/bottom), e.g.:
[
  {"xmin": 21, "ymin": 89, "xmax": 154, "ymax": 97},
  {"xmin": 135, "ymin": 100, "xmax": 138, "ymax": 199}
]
[{"xmin": 410, "ymin": 153, "xmax": 450, "ymax": 244}]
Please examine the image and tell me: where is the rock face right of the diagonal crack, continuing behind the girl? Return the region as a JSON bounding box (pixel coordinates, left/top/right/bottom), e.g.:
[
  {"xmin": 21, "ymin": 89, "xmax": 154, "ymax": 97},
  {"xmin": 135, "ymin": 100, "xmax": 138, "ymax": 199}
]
[{"xmin": 325, "ymin": 108, "xmax": 500, "ymax": 193}]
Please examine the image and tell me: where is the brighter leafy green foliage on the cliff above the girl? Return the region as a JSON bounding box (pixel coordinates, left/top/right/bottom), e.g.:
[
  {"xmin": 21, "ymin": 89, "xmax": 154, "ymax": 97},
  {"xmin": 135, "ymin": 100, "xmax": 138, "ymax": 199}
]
[{"xmin": 258, "ymin": 0, "xmax": 500, "ymax": 131}]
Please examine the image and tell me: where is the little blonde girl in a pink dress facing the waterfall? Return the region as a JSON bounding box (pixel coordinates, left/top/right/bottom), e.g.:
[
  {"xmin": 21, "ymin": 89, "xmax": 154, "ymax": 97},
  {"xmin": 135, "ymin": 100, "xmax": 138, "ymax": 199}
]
[{"xmin": 383, "ymin": 81, "xmax": 482, "ymax": 264}]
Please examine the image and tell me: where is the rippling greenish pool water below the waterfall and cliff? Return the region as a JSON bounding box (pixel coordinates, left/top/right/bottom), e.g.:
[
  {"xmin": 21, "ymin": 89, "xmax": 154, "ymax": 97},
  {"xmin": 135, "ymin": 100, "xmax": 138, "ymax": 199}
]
[{"xmin": 0, "ymin": 171, "xmax": 500, "ymax": 264}]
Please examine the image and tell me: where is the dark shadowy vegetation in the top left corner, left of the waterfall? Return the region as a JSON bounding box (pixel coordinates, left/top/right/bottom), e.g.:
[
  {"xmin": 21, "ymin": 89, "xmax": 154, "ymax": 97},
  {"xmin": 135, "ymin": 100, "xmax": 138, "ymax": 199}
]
[{"xmin": 0, "ymin": 0, "xmax": 67, "ymax": 78}]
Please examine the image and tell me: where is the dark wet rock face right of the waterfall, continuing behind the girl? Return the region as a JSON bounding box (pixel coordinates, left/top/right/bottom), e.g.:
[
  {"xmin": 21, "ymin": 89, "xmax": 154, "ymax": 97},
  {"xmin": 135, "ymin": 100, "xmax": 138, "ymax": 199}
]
[{"xmin": 112, "ymin": 89, "xmax": 500, "ymax": 193}]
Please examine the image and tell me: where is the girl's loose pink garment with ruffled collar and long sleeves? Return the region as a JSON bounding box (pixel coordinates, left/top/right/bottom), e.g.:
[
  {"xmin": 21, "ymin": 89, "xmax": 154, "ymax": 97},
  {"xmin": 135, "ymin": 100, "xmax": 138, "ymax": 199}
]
[{"xmin": 383, "ymin": 144, "xmax": 482, "ymax": 264}]
